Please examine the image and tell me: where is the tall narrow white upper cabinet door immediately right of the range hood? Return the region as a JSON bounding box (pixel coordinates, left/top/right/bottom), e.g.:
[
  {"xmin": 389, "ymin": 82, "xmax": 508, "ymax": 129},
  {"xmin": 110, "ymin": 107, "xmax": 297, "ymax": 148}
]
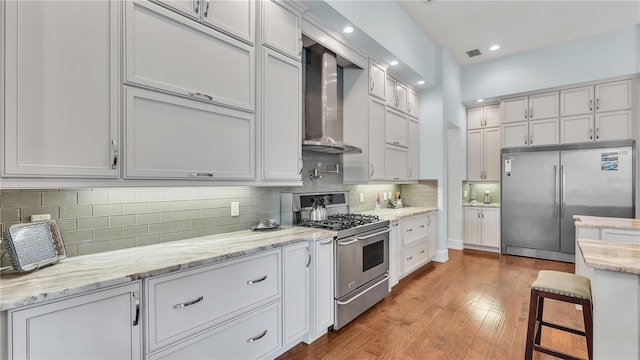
[{"xmin": 369, "ymin": 98, "xmax": 387, "ymax": 180}]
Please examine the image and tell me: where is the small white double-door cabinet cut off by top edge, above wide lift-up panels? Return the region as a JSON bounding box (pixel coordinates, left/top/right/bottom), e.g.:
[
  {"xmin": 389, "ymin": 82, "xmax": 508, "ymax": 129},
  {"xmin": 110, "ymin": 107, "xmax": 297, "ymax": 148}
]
[{"xmin": 156, "ymin": 0, "xmax": 256, "ymax": 44}]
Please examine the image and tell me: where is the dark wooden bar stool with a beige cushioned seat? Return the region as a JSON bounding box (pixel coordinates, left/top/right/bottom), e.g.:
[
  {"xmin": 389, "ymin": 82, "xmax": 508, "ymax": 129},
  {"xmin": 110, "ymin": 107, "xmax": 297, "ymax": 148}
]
[{"xmin": 524, "ymin": 270, "xmax": 593, "ymax": 360}]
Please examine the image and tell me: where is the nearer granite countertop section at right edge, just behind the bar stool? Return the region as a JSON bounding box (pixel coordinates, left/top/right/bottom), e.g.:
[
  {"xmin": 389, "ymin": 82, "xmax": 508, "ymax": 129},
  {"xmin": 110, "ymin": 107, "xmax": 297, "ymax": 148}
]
[{"xmin": 578, "ymin": 239, "xmax": 640, "ymax": 275}]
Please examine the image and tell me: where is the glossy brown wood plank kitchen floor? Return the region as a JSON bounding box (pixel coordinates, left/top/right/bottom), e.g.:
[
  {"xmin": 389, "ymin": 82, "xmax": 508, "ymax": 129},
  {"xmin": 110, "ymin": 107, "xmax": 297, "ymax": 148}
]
[{"xmin": 279, "ymin": 250, "xmax": 587, "ymax": 360}]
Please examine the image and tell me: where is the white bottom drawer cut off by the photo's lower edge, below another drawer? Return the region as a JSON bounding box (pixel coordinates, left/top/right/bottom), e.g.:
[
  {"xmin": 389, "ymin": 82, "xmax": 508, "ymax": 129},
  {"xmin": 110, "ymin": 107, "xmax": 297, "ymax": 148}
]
[{"xmin": 148, "ymin": 302, "xmax": 282, "ymax": 360}]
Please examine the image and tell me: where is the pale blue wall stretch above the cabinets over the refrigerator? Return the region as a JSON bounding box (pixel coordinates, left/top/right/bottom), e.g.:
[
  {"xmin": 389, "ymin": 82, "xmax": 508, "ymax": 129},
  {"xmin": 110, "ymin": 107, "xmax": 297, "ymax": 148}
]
[{"xmin": 462, "ymin": 25, "xmax": 640, "ymax": 103}]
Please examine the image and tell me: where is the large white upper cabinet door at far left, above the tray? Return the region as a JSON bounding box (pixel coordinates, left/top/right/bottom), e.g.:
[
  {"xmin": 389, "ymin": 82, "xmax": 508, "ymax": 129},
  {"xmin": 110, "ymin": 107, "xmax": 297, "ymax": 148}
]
[{"xmin": 2, "ymin": 1, "xmax": 120, "ymax": 178}]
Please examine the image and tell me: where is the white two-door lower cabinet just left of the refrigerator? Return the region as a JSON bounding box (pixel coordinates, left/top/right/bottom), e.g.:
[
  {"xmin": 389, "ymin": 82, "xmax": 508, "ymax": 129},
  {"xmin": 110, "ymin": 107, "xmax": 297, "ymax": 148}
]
[{"xmin": 464, "ymin": 207, "xmax": 500, "ymax": 249}]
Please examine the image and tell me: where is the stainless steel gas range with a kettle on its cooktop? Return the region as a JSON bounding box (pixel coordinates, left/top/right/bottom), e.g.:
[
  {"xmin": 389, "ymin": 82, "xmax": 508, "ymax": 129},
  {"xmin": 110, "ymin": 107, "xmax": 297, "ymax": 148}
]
[{"xmin": 281, "ymin": 192, "xmax": 390, "ymax": 330}]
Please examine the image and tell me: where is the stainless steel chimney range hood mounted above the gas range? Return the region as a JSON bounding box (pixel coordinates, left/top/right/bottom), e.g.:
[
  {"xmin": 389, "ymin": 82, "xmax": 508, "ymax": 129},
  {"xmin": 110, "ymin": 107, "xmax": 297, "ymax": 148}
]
[{"xmin": 302, "ymin": 44, "xmax": 362, "ymax": 154}]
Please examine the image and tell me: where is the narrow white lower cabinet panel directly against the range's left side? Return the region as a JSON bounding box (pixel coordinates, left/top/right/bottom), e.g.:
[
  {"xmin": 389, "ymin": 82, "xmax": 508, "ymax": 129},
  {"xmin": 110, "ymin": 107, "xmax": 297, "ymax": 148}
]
[{"xmin": 305, "ymin": 239, "xmax": 334, "ymax": 343}]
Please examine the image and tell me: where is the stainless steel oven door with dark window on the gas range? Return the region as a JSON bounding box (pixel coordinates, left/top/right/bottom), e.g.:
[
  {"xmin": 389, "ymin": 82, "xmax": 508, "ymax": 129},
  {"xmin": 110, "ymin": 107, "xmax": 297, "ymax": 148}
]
[{"xmin": 336, "ymin": 227, "xmax": 390, "ymax": 299}]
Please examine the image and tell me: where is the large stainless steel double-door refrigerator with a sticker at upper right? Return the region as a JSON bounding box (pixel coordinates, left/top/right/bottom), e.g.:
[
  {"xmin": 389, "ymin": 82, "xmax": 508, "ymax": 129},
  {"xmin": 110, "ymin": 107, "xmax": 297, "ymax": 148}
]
[{"xmin": 501, "ymin": 141, "xmax": 635, "ymax": 262}]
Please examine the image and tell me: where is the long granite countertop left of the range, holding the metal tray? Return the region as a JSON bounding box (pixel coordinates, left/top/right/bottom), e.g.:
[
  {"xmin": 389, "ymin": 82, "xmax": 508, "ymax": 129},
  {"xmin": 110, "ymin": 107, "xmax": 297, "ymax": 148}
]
[{"xmin": 0, "ymin": 226, "xmax": 335, "ymax": 311}]
